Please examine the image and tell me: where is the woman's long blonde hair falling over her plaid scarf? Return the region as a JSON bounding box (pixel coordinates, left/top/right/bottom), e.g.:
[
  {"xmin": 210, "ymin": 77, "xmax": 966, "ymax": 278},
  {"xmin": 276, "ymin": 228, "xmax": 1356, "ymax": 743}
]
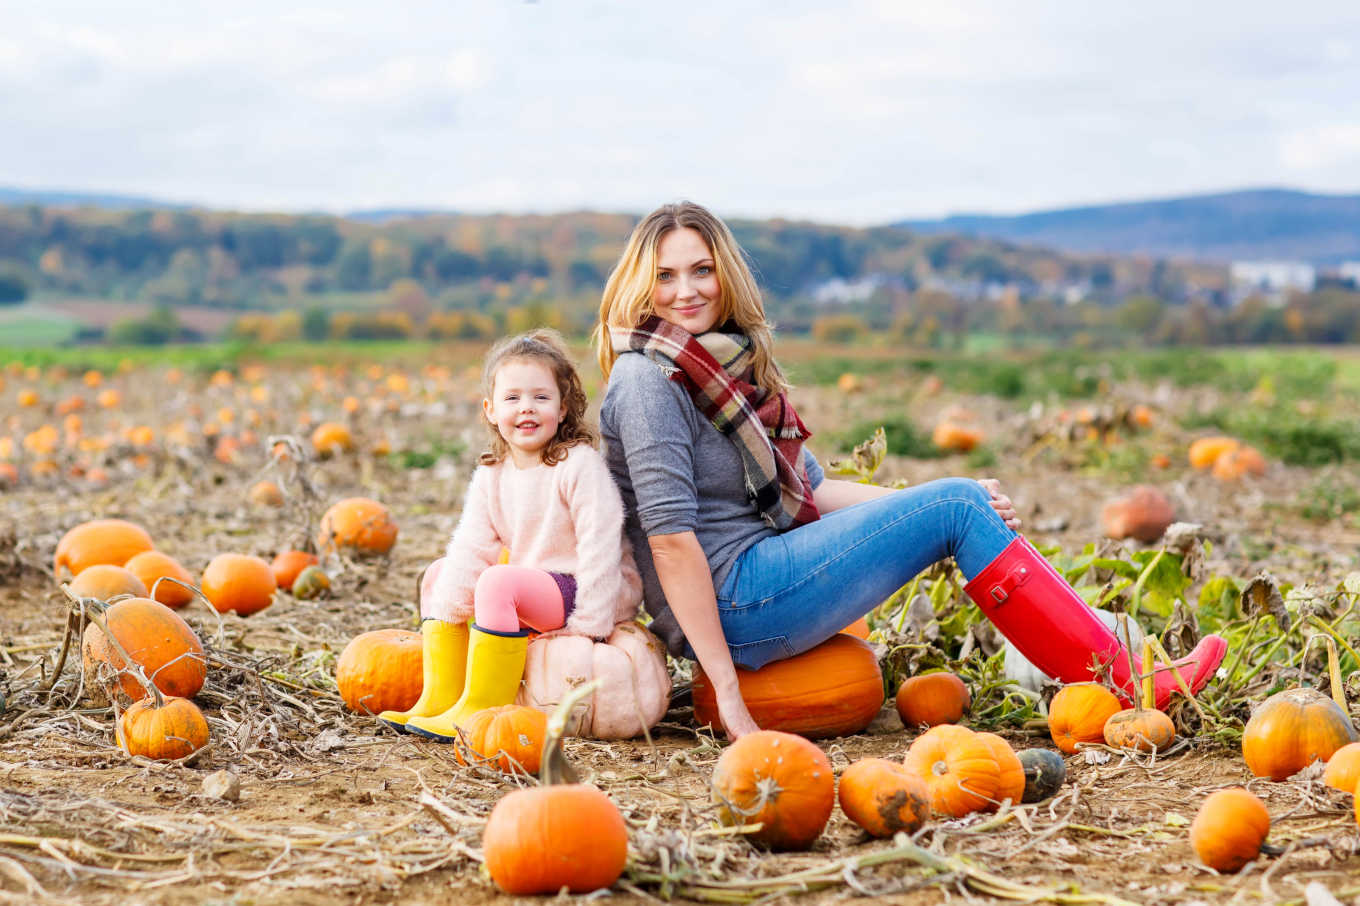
[{"xmin": 592, "ymin": 201, "xmax": 789, "ymax": 393}]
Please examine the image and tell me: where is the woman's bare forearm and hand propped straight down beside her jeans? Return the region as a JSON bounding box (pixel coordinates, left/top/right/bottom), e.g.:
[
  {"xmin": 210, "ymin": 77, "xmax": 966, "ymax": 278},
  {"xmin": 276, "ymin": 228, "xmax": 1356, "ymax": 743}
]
[{"xmin": 647, "ymin": 532, "xmax": 760, "ymax": 740}]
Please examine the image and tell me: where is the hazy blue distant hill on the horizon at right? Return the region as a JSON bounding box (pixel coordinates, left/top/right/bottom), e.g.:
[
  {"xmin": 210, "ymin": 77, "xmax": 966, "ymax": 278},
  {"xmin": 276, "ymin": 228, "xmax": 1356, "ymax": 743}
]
[{"xmin": 894, "ymin": 189, "xmax": 1360, "ymax": 265}]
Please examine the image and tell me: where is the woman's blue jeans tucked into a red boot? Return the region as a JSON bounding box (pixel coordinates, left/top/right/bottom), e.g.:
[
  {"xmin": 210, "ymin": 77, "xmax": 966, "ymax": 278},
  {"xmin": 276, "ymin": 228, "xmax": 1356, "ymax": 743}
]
[{"xmin": 718, "ymin": 477, "xmax": 1016, "ymax": 669}]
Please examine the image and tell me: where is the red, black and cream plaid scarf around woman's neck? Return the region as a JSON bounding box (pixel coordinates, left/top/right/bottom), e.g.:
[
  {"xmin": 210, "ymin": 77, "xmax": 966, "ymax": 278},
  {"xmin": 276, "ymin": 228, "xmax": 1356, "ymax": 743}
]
[{"xmin": 609, "ymin": 316, "xmax": 817, "ymax": 532}]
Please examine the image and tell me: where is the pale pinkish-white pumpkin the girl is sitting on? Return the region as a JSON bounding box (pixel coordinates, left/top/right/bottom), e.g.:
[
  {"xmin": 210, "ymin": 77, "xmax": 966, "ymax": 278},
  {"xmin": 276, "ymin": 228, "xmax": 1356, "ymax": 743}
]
[{"xmin": 515, "ymin": 622, "xmax": 670, "ymax": 739}]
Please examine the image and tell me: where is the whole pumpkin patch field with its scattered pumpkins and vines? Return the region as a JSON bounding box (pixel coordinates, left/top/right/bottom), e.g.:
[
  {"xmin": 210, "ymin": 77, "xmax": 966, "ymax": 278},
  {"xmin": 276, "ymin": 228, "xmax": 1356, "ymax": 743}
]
[{"xmin": 0, "ymin": 340, "xmax": 1360, "ymax": 906}]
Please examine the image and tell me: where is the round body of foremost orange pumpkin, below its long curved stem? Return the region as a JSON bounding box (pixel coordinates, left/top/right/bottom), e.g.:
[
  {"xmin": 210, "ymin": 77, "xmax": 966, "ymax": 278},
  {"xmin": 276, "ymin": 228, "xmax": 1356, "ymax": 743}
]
[{"xmin": 481, "ymin": 784, "xmax": 628, "ymax": 896}]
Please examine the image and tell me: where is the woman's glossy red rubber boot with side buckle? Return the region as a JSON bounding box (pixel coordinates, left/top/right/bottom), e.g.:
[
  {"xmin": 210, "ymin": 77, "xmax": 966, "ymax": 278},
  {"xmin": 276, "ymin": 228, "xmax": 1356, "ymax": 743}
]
[{"xmin": 964, "ymin": 536, "xmax": 1228, "ymax": 709}]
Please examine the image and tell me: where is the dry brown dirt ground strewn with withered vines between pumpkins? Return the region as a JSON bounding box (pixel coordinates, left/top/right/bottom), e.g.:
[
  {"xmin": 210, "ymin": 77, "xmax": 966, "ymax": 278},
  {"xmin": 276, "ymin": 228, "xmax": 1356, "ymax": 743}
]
[{"xmin": 0, "ymin": 364, "xmax": 1360, "ymax": 906}]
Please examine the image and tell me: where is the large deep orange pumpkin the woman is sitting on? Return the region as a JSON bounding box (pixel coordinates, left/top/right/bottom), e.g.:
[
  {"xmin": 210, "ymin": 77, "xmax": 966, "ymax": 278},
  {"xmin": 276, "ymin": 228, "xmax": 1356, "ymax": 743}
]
[{"xmin": 694, "ymin": 633, "xmax": 883, "ymax": 739}]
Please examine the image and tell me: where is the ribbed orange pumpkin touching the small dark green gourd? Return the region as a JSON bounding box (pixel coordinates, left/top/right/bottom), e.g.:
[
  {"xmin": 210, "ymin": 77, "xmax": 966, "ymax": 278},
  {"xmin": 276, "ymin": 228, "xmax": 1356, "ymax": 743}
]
[{"xmin": 903, "ymin": 724, "xmax": 1001, "ymax": 818}]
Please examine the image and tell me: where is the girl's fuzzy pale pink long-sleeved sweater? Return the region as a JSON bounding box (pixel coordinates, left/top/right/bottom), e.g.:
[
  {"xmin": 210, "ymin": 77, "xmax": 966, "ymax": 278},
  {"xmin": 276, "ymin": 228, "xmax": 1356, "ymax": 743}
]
[{"xmin": 426, "ymin": 445, "xmax": 642, "ymax": 639}]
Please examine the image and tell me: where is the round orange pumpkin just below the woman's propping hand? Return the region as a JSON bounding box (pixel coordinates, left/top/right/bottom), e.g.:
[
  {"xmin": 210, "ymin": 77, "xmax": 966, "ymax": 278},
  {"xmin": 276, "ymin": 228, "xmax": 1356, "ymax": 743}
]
[{"xmin": 710, "ymin": 731, "xmax": 836, "ymax": 849}]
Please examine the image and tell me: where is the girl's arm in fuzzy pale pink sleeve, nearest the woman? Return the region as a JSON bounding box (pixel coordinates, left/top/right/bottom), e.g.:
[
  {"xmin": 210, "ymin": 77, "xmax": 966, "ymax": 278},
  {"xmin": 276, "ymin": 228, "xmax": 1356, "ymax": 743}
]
[{"xmin": 558, "ymin": 446, "xmax": 641, "ymax": 639}]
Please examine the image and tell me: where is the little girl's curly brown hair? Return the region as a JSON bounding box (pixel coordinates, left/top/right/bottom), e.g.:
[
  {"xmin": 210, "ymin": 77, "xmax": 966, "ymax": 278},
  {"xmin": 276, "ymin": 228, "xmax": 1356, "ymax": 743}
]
[{"xmin": 477, "ymin": 328, "xmax": 598, "ymax": 465}]
